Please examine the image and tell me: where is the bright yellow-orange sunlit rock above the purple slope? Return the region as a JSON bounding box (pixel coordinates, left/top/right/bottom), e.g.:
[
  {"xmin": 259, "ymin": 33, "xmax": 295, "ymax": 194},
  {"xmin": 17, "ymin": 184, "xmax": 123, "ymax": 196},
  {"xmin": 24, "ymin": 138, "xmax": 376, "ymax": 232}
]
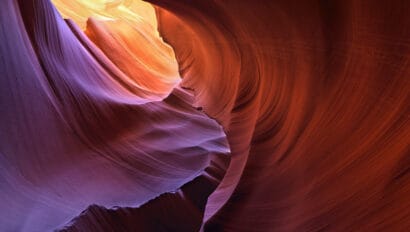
[{"xmin": 52, "ymin": 0, "xmax": 180, "ymax": 97}]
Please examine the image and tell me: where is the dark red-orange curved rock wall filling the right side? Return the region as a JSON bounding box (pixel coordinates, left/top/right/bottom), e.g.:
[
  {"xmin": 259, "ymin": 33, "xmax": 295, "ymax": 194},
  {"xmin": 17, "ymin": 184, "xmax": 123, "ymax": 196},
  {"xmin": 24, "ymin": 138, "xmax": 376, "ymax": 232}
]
[{"xmin": 152, "ymin": 0, "xmax": 410, "ymax": 231}]
